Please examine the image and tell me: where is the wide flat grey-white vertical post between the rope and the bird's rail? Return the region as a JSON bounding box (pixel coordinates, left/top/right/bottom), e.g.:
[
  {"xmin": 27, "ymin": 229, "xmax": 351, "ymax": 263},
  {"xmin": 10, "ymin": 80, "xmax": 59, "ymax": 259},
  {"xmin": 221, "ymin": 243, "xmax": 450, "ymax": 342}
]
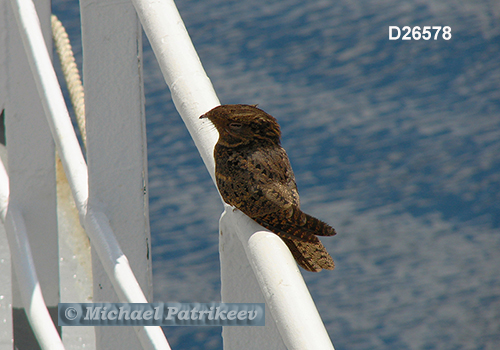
[{"xmin": 80, "ymin": 0, "xmax": 152, "ymax": 349}]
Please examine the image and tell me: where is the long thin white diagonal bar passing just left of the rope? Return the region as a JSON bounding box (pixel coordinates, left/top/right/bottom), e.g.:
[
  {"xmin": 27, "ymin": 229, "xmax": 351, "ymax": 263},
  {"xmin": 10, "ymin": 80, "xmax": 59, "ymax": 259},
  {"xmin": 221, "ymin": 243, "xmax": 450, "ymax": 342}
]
[{"xmin": 12, "ymin": 0, "xmax": 170, "ymax": 349}]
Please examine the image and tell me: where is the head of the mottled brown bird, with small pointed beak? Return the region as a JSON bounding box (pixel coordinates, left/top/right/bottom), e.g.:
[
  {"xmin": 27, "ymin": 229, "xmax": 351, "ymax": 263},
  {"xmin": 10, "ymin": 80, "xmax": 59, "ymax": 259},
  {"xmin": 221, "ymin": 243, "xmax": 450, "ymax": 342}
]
[{"xmin": 200, "ymin": 105, "xmax": 281, "ymax": 147}]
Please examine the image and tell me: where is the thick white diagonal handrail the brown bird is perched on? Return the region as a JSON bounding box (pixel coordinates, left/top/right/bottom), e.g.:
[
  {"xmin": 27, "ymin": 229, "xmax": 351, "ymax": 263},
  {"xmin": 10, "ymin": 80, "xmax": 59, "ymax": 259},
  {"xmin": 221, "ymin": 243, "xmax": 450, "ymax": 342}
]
[{"xmin": 132, "ymin": 0, "xmax": 333, "ymax": 350}]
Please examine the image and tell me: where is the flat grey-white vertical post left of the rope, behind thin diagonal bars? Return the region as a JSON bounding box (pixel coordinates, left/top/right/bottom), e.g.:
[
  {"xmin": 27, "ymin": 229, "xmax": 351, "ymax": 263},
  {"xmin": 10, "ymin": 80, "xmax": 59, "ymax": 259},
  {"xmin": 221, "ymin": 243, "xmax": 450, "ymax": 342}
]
[{"xmin": 4, "ymin": 0, "xmax": 59, "ymax": 346}]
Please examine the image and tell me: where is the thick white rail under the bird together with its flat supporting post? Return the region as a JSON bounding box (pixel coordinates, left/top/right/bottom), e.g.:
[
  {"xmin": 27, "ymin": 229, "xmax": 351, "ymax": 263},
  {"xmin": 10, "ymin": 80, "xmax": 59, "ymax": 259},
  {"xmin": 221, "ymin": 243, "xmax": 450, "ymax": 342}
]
[{"xmin": 133, "ymin": 0, "xmax": 333, "ymax": 350}]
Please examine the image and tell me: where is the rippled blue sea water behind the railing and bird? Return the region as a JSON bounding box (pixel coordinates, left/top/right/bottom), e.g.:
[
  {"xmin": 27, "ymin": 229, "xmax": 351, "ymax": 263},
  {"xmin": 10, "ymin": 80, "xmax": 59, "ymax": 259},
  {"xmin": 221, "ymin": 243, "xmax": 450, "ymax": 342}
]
[{"xmin": 53, "ymin": 0, "xmax": 500, "ymax": 350}]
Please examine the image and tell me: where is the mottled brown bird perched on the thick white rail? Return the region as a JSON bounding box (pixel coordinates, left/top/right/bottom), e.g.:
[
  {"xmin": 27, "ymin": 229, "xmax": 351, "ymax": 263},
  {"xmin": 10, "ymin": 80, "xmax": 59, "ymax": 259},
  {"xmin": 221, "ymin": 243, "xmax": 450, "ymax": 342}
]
[{"xmin": 200, "ymin": 104, "xmax": 336, "ymax": 272}]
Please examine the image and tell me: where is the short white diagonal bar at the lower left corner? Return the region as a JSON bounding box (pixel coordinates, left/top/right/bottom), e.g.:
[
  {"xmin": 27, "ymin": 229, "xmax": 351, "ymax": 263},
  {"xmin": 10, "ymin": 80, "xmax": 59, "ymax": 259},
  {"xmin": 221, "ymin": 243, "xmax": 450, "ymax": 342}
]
[{"xmin": 0, "ymin": 160, "xmax": 64, "ymax": 350}]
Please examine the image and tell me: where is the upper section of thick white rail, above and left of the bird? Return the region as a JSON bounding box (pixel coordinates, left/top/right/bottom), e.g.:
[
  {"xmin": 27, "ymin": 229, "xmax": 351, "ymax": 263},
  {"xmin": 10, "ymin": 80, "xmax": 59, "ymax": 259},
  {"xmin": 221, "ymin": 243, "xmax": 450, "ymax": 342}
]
[{"xmin": 133, "ymin": 0, "xmax": 220, "ymax": 179}]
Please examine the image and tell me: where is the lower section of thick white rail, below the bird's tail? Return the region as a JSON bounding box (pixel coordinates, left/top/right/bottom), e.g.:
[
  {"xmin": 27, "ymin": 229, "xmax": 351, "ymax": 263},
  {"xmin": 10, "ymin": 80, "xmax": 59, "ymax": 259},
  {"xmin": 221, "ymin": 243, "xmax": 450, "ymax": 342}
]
[{"xmin": 221, "ymin": 209, "xmax": 334, "ymax": 350}]
